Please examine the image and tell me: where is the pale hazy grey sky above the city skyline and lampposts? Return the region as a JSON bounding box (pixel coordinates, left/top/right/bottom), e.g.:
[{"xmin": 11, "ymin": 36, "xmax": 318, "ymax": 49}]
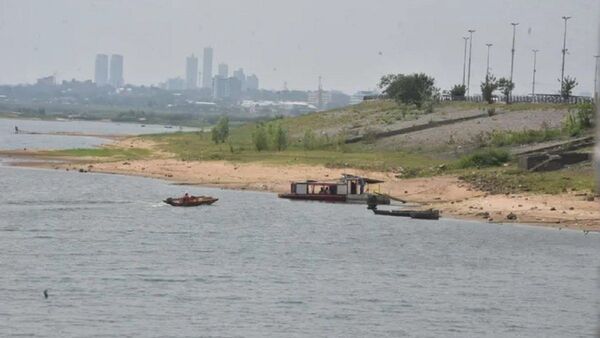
[{"xmin": 0, "ymin": 0, "xmax": 600, "ymax": 93}]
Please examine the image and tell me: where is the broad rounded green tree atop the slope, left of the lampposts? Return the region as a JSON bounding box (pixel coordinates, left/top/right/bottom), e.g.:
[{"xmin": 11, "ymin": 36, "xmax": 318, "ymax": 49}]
[{"xmin": 379, "ymin": 73, "xmax": 435, "ymax": 108}]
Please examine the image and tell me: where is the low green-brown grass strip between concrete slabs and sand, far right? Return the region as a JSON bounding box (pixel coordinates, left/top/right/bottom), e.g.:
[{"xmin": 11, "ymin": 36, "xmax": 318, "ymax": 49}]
[{"xmin": 460, "ymin": 165, "xmax": 594, "ymax": 194}]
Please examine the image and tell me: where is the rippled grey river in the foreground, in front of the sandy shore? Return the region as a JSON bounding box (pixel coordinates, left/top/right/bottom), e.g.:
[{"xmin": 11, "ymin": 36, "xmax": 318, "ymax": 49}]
[{"xmin": 0, "ymin": 167, "xmax": 600, "ymax": 337}]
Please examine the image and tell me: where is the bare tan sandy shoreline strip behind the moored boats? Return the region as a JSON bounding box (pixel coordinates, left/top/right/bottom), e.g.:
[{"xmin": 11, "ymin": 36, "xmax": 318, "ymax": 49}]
[{"xmin": 0, "ymin": 138, "xmax": 600, "ymax": 232}]
